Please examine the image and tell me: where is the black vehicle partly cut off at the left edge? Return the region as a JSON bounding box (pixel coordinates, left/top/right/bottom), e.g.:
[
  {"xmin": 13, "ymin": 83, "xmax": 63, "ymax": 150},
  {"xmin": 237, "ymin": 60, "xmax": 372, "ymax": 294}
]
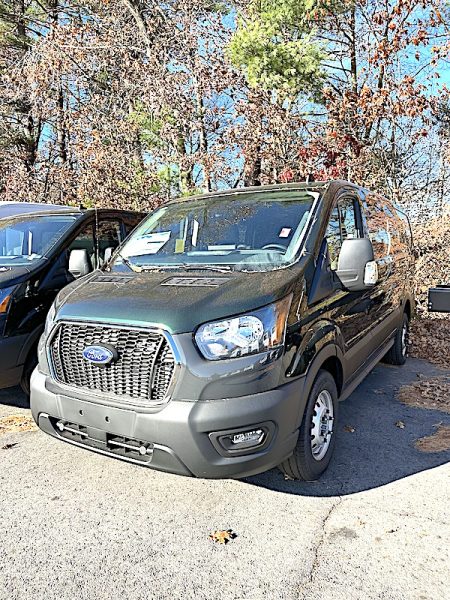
[{"xmin": 0, "ymin": 202, "xmax": 144, "ymax": 393}]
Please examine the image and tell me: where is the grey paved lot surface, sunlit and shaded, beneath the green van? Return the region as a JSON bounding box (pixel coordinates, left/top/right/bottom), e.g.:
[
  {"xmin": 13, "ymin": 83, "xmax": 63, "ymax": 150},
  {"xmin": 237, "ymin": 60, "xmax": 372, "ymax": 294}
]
[{"xmin": 0, "ymin": 359, "xmax": 450, "ymax": 600}]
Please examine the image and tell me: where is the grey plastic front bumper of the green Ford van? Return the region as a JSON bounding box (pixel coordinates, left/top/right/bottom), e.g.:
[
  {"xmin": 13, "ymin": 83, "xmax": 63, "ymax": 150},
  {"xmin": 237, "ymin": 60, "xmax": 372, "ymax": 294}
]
[{"xmin": 31, "ymin": 369, "xmax": 305, "ymax": 478}]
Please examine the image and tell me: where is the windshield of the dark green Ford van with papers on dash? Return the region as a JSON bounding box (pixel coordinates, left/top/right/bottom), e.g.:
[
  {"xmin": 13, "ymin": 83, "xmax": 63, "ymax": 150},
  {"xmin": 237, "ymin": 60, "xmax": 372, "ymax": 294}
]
[{"xmin": 114, "ymin": 190, "xmax": 319, "ymax": 271}]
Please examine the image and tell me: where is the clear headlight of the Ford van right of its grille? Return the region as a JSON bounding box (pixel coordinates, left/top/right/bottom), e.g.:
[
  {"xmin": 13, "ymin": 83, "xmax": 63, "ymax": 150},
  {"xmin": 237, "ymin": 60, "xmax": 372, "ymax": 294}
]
[{"xmin": 195, "ymin": 296, "xmax": 292, "ymax": 360}]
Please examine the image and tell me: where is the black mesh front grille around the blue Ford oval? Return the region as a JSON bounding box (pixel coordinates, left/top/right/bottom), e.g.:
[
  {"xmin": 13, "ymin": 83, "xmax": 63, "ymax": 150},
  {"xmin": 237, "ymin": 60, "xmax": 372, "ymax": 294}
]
[{"xmin": 50, "ymin": 322, "xmax": 175, "ymax": 404}]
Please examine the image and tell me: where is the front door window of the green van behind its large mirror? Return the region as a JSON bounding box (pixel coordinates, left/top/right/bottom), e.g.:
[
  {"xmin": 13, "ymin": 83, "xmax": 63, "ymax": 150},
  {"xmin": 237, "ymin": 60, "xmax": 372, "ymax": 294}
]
[{"xmin": 325, "ymin": 197, "xmax": 360, "ymax": 271}]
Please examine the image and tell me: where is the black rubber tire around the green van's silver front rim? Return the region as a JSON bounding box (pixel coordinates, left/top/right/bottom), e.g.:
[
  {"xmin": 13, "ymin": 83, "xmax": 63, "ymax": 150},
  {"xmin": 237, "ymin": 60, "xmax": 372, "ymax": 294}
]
[{"xmin": 279, "ymin": 370, "xmax": 338, "ymax": 481}]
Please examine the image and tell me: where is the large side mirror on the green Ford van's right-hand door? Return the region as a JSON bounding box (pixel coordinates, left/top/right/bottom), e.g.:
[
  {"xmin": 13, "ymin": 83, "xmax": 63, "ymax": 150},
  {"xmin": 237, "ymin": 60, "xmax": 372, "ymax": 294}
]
[{"xmin": 336, "ymin": 238, "xmax": 378, "ymax": 292}]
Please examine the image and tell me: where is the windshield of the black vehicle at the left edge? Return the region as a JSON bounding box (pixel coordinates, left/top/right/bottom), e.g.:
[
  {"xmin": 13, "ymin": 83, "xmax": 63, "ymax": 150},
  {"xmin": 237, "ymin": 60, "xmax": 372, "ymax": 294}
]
[{"xmin": 0, "ymin": 214, "xmax": 77, "ymax": 267}]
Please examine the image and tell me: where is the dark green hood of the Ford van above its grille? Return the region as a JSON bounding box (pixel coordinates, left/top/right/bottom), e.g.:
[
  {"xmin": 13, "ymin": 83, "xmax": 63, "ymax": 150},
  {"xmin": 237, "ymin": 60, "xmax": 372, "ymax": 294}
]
[{"xmin": 56, "ymin": 264, "xmax": 301, "ymax": 334}]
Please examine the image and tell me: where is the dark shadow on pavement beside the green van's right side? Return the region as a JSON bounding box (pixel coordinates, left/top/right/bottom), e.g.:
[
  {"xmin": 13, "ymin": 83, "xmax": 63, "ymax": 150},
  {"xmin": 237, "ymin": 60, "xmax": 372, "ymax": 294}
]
[{"xmin": 245, "ymin": 359, "xmax": 450, "ymax": 497}]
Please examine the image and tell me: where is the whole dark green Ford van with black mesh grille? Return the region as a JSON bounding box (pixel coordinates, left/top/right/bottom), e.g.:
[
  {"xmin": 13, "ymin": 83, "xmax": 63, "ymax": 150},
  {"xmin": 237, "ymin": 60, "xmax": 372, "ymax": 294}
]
[{"xmin": 31, "ymin": 181, "xmax": 414, "ymax": 480}]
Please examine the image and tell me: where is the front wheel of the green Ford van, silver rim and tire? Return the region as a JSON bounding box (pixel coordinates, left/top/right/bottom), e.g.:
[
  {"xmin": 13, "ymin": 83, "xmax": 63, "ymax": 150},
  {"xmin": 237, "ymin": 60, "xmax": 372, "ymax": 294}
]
[{"xmin": 280, "ymin": 371, "xmax": 338, "ymax": 481}]
